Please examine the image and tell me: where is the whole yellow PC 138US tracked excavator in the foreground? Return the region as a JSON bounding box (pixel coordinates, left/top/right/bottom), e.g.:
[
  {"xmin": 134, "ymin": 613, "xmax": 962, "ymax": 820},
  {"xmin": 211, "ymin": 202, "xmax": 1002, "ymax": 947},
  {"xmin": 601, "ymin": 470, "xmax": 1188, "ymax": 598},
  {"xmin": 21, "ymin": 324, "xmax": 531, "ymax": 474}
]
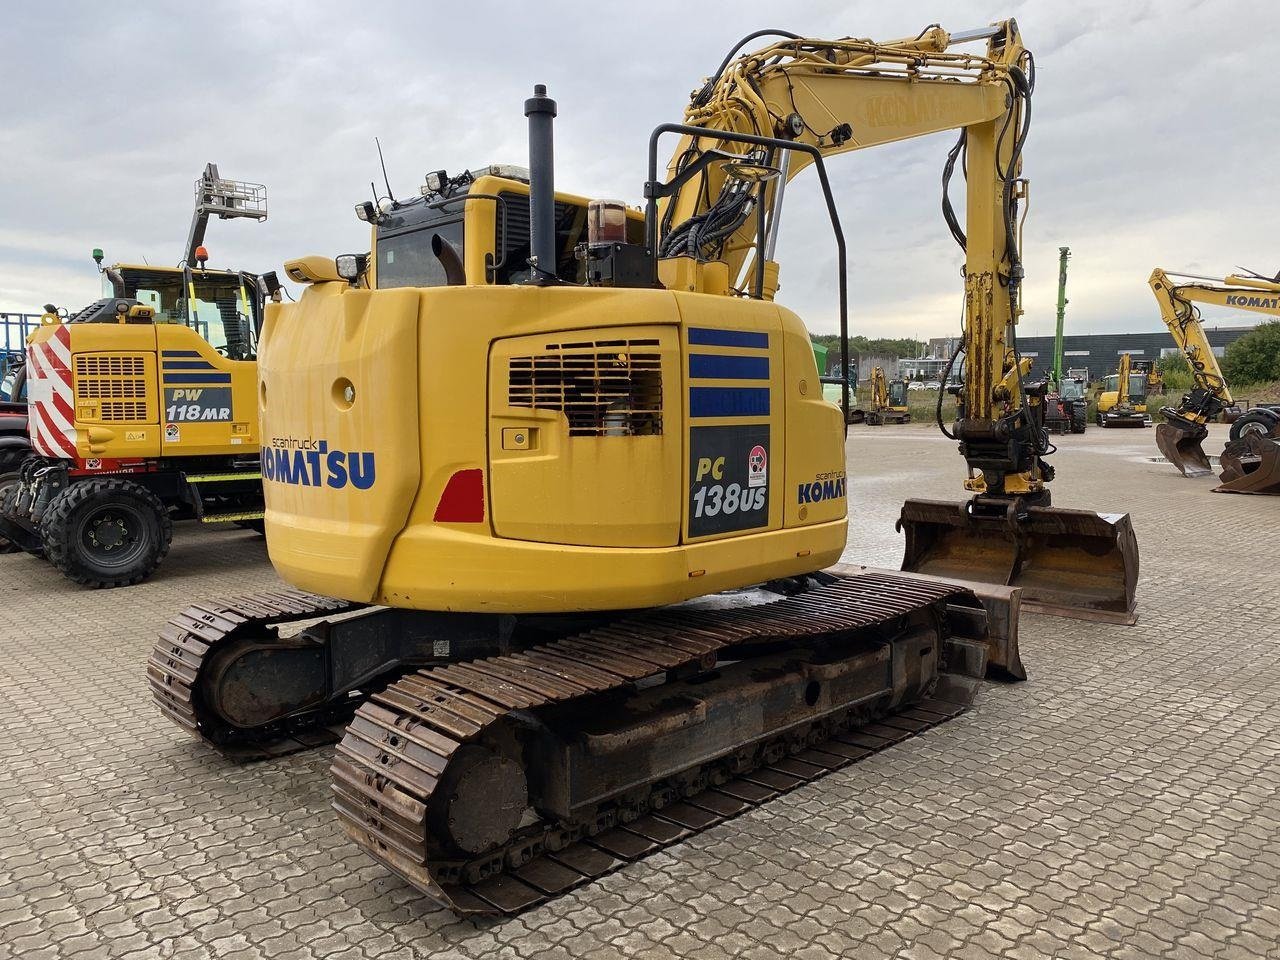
[{"xmin": 148, "ymin": 20, "xmax": 1137, "ymax": 914}]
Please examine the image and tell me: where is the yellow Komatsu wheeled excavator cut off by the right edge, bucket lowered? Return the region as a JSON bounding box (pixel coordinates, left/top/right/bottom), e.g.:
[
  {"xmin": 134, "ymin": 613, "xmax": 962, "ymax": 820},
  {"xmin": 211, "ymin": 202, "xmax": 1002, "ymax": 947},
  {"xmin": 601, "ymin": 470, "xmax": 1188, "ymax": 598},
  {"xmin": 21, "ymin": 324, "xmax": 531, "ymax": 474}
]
[{"xmin": 1149, "ymin": 266, "xmax": 1280, "ymax": 494}]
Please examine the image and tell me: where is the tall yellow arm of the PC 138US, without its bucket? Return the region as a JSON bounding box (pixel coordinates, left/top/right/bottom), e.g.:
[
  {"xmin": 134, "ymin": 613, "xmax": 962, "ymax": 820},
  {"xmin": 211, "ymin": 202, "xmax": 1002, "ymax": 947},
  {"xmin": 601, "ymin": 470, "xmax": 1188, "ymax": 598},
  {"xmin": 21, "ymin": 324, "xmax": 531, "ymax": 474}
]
[{"xmin": 658, "ymin": 20, "xmax": 1052, "ymax": 504}]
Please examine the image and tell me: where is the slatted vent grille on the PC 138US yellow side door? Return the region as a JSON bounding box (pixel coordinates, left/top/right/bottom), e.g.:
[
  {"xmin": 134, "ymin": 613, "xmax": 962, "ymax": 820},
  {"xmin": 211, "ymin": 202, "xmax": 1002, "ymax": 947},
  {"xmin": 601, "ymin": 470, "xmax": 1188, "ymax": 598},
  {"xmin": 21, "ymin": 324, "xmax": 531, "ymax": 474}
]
[{"xmin": 507, "ymin": 340, "xmax": 662, "ymax": 436}]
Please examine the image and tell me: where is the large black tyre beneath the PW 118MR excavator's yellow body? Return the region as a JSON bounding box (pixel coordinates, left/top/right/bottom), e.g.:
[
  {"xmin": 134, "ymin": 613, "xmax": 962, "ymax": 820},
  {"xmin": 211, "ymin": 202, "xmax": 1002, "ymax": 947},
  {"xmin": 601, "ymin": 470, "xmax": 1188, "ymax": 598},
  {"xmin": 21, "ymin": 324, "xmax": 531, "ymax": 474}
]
[{"xmin": 40, "ymin": 477, "xmax": 173, "ymax": 588}]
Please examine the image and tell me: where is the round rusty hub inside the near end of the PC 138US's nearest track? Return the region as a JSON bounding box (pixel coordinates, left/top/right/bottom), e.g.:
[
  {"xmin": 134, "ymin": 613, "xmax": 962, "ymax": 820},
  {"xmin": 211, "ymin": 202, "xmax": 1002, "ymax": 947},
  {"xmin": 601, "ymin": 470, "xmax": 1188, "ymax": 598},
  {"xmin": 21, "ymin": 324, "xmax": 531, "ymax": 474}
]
[{"xmin": 431, "ymin": 744, "xmax": 529, "ymax": 854}]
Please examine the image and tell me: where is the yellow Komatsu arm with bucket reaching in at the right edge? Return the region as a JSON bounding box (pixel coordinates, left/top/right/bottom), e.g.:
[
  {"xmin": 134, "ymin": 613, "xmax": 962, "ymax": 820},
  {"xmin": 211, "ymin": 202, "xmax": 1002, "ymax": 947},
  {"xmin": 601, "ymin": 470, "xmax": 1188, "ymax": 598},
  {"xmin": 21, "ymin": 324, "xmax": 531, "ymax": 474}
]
[{"xmin": 1149, "ymin": 266, "xmax": 1280, "ymax": 477}]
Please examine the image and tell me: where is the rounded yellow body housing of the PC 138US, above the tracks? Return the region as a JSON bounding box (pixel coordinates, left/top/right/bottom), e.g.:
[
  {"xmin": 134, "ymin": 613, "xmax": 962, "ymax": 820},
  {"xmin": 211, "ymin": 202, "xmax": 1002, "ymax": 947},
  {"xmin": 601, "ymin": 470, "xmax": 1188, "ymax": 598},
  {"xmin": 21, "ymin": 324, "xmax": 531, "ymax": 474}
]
[{"xmin": 259, "ymin": 184, "xmax": 846, "ymax": 613}]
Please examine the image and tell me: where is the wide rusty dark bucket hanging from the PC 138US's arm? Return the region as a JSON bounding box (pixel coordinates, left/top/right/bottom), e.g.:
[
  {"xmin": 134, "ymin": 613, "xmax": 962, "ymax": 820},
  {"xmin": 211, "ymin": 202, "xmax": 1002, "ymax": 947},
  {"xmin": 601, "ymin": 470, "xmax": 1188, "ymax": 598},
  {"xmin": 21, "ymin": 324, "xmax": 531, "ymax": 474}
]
[{"xmin": 897, "ymin": 500, "xmax": 1138, "ymax": 623}]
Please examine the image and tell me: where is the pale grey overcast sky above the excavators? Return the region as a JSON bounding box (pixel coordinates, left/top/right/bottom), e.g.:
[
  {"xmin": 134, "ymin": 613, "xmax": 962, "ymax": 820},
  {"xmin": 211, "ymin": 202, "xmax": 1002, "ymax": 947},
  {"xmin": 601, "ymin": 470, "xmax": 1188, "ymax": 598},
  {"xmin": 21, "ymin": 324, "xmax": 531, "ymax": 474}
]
[{"xmin": 0, "ymin": 0, "xmax": 1280, "ymax": 338}]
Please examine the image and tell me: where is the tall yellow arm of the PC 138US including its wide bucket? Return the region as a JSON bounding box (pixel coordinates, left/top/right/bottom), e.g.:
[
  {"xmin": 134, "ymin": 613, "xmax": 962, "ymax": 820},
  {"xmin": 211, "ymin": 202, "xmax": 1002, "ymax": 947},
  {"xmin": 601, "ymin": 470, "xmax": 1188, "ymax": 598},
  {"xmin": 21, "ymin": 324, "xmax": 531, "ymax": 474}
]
[{"xmin": 646, "ymin": 19, "xmax": 1137, "ymax": 622}]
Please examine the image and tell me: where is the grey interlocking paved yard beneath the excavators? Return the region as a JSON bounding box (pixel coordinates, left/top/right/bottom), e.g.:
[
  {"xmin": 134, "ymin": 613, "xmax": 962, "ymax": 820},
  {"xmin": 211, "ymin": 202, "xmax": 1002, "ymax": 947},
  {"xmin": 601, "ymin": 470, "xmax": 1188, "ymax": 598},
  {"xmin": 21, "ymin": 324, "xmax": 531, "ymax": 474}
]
[{"xmin": 0, "ymin": 426, "xmax": 1280, "ymax": 960}]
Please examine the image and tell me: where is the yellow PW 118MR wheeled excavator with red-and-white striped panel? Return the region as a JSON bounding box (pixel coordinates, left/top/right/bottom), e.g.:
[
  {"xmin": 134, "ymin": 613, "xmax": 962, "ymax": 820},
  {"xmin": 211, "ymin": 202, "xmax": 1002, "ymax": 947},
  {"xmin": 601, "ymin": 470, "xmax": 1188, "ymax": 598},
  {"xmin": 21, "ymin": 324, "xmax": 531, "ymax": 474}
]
[{"xmin": 0, "ymin": 164, "xmax": 278, "ymax": 588}]
